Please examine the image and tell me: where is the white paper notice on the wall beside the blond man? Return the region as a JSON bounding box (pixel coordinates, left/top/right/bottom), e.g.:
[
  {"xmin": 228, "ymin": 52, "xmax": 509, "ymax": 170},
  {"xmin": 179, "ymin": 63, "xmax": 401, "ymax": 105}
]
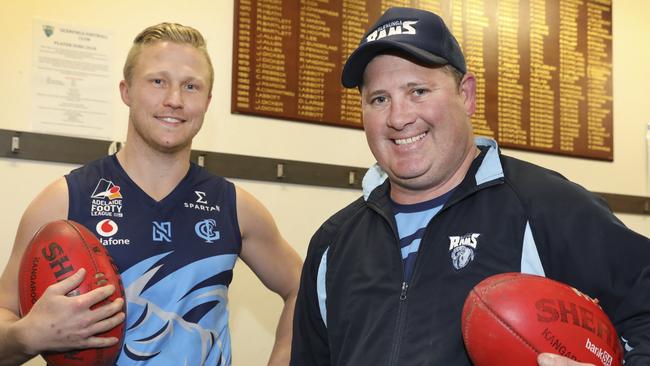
[{"xmin": 32, "ymin": 19, "xmax": 116, "ymax": 140}]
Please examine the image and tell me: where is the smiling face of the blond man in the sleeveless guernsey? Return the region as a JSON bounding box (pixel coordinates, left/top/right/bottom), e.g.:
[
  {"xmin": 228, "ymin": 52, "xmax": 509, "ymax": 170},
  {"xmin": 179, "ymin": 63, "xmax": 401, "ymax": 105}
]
[{"xmin": 120, "ymin": 41, "xmax": 211, "ymax": 153}]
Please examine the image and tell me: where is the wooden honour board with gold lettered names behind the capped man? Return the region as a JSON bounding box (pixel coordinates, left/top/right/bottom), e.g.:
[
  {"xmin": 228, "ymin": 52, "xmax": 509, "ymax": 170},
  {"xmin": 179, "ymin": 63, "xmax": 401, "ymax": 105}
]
[{"xmin": 232, "ymin": 0, "xmax": 613, "ymax": 160}]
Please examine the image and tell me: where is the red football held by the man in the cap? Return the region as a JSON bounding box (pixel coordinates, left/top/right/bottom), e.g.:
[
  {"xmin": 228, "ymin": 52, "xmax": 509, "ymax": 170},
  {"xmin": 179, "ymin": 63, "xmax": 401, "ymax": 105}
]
[{"xmin": 462, "ymin": 273, "xmax": 623, "ymax": 366}]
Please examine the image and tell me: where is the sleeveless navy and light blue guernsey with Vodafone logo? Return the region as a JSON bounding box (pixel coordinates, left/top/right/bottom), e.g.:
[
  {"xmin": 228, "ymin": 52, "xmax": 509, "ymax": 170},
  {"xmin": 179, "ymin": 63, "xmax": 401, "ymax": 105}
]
[{"xmin": 66, "ymin": 155, "xmax": 241, "ymax": 366}]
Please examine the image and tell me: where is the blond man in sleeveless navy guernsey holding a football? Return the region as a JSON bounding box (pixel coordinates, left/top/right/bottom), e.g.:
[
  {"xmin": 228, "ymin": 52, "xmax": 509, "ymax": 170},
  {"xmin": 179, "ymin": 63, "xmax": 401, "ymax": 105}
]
[{"xmin": 0, "ymin": 23, "xmax": 301, "ymax": 366}]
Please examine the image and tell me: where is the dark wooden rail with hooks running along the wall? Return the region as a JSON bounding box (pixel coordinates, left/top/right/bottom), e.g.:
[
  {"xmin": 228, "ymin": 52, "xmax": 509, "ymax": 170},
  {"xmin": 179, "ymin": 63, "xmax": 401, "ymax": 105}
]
[{"xmin": 0, "ymin": 129, "xmax": 650, "ymax": 215}]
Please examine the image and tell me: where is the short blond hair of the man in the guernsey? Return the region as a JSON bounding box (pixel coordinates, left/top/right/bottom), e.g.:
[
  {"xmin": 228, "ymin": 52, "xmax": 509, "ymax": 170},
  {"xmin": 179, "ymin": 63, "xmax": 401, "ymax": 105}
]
[{"xmin": 123, "ymin": 23, "xmax": 214, "ymax": 90}]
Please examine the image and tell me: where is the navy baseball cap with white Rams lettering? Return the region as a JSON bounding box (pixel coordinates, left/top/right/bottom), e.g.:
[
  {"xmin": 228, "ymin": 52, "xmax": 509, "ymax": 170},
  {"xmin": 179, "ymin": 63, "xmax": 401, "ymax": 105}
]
[{"xmin": 341, "ymin": 8, "xmax": 467, "ymax": 88}]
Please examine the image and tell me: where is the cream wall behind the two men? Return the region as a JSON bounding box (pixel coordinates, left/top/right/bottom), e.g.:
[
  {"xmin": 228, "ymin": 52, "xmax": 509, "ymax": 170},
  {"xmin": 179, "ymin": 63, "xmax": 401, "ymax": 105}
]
[{"xmin": 0, "ymin": 0, "xmax": 650, "ymax": 365}]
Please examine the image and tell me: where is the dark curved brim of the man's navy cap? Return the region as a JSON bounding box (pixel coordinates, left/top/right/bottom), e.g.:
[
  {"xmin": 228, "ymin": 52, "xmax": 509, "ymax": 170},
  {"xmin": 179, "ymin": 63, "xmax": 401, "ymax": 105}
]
[{"xmin": 341, "ymin": 39, "xmax": 449, "ymax": 88}]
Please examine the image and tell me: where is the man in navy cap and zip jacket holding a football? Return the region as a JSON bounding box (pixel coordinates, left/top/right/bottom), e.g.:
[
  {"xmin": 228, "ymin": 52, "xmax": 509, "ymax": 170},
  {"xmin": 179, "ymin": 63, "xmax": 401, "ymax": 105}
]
[{"xmin": 292, "ymin": 8, "xmax": 650, "ymax": 366}]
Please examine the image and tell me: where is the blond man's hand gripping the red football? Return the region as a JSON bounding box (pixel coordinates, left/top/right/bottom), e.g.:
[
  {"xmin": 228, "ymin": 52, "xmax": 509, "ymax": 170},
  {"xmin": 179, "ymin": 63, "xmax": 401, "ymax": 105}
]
[{"xmin": 10, "ymin": 268, "xmax": 125, "ymax": 355}]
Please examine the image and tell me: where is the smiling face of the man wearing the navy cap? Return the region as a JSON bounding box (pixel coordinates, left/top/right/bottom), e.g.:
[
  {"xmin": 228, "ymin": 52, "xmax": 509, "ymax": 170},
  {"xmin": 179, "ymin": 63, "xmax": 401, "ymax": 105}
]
[{"xmin": 361, "ymin": 54, "xmax": 477, "ymax": 204}]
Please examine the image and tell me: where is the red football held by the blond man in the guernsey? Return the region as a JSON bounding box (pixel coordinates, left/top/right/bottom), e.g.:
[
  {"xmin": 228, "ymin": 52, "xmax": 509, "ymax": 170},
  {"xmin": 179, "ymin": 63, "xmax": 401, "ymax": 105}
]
[{"xmin": 18, "ymin": 220, "xmax": 124, "ymax": 366}]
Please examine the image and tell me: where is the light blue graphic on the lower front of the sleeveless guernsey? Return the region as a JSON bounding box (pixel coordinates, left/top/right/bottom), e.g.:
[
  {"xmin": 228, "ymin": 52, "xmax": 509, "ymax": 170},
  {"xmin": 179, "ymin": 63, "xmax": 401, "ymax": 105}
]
[{"xmin": 117, "ymin": 252, "xmax": 237, "ymax": 365}]
